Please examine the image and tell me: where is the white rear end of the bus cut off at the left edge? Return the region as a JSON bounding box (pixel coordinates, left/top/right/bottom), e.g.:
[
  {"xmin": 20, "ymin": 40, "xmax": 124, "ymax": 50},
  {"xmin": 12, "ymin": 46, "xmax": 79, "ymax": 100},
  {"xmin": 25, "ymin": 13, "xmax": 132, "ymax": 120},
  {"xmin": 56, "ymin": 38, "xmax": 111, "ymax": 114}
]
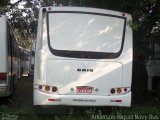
[{"xmin": 0, "ymin": 15, "xmax": 8, "ymax": 97}]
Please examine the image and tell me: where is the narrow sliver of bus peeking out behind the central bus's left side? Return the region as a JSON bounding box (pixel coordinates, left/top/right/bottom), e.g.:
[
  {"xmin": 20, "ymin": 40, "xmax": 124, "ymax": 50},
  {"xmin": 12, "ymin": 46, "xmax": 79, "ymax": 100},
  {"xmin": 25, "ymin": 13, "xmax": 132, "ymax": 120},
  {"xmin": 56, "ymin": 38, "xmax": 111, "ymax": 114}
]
[{"xmin": 29, "ymin": 41, "xmax": 35, "ymax": 76}]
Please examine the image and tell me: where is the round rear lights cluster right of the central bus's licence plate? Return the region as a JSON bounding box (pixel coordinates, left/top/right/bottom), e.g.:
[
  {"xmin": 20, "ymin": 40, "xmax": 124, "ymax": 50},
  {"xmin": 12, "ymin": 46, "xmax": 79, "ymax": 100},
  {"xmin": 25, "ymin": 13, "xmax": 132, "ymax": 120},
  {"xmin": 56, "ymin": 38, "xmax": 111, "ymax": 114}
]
[{"xmin": 110, "ymin": 87, "xmax": 130, "ymax": 94}]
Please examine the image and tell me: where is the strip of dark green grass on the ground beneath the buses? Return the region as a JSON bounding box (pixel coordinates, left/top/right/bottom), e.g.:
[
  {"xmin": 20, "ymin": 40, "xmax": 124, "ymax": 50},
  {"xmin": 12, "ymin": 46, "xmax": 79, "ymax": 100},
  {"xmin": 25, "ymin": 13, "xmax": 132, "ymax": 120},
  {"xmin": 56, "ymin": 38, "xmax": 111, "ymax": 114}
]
[{"xmin": 0, "ymin": 105, "xmax": 160, "ymax": 120}]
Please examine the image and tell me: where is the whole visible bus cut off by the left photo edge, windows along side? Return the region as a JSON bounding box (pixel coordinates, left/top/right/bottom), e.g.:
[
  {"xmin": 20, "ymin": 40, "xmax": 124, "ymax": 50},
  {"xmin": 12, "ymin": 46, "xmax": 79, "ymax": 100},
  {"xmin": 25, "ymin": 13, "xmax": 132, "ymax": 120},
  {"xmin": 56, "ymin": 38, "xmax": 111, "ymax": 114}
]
[{"xmin": 0, "ymin": 15, "xmax": 19, "ymax": 97}]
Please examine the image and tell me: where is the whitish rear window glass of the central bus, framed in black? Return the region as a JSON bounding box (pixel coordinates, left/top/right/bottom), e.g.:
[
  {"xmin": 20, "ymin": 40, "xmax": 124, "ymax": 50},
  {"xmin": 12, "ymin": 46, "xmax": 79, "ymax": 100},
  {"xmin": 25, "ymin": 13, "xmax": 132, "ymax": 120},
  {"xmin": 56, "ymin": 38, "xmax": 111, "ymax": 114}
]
[{"xmin": 47, "ymin": 12, "xmax": 126, "ymax": 58}]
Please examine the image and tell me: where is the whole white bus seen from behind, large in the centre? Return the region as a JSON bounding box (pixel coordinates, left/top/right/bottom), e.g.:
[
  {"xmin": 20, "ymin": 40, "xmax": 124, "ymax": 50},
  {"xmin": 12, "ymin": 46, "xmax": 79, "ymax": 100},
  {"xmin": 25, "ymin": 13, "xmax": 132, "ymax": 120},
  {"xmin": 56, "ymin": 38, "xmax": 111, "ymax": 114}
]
[{"xmin": 34, "ymin": 7, "xmax": 133, "ymax": 106}]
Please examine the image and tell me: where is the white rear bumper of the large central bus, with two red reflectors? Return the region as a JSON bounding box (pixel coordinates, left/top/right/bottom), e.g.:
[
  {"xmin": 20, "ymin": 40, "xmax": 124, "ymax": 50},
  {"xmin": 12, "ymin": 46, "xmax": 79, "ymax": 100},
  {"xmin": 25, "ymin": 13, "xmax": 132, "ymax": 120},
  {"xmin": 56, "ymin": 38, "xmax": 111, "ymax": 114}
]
[{"xmin": 34, "ymin": 89, "xmax": 131, "ymax": 107}]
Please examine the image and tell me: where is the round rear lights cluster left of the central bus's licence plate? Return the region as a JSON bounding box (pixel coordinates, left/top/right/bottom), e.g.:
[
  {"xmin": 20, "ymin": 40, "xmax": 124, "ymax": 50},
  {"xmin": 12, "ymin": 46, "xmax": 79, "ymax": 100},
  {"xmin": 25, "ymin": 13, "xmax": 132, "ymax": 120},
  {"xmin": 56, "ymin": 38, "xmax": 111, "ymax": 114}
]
[{"xmin": 38, "ymin": 85, "xmax": 58, "ymax": 92}]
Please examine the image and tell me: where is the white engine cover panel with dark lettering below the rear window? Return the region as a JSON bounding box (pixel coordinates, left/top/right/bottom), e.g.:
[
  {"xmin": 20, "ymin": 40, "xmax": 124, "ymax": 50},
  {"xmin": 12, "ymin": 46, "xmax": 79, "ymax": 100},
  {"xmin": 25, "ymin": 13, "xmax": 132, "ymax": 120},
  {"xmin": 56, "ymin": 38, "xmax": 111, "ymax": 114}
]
[{"xmin": 46, "ymin": 60, "xmax": 122, "ymax": 95}]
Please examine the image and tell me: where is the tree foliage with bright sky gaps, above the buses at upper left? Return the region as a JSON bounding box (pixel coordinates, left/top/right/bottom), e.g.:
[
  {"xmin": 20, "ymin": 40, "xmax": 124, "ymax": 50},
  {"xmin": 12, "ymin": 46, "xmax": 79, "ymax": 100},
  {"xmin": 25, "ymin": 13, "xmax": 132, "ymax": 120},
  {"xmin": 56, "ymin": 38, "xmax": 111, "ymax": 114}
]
[{"xmin": 0, "ymin": 0, "xmax": 40, "ymax": 48}]
